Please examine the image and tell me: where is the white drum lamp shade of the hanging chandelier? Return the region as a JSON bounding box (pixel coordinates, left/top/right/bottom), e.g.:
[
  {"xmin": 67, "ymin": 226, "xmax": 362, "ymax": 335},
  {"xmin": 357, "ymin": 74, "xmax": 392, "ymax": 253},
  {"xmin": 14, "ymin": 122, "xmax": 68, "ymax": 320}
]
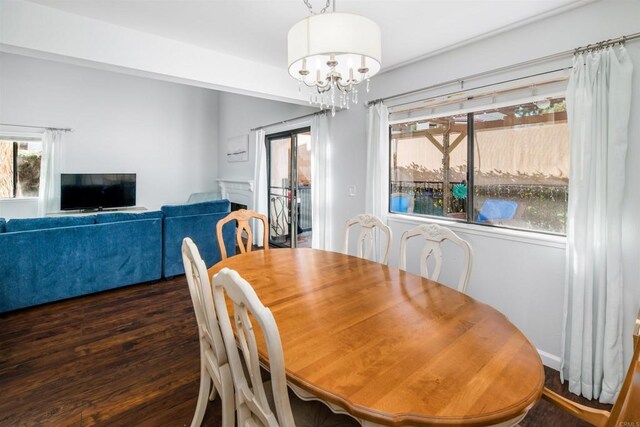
[{"xmin": 288, "ymin": 12, "xmax": 381, "ymax": 81}]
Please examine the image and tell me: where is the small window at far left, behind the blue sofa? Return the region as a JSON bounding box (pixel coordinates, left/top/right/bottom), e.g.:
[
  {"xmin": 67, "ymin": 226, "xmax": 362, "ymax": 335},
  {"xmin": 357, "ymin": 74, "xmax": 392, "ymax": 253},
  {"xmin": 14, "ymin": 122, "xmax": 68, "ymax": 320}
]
[{"xmin": 0, "ymin": 135, "xmax": 42, "ymax": 199}]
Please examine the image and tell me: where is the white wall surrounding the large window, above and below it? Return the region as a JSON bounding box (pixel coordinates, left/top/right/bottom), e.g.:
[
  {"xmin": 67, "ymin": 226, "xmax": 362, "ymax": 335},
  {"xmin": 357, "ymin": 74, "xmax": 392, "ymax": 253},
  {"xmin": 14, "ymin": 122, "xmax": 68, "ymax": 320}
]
[{"xmin": 331, "ymin": 0, "xmax": 640, "ymax": 367}]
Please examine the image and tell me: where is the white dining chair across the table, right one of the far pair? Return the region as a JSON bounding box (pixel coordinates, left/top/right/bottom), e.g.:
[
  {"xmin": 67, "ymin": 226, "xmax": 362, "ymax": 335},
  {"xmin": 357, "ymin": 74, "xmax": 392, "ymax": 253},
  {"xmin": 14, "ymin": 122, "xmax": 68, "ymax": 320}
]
[{"xmin": 399, "ymin": 224, "xmax": 473, "ymax": 293}]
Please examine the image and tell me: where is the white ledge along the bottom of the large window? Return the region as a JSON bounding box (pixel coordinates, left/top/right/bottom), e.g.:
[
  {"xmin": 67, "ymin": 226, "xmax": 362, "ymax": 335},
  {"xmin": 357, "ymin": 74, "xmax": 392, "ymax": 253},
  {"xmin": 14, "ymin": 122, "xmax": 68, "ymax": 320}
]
[{"xmin": 387, "ymin": 213, "xmax": 567, "ymax": 249}]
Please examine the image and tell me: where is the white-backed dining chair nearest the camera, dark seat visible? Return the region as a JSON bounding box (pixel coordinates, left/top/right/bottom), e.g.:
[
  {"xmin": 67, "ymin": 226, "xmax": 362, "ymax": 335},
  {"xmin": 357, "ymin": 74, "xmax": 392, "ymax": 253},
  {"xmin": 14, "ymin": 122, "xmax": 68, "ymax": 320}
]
[{"xmin": 213, "ymin": 268, "xmax": 359, "ymax": 427}]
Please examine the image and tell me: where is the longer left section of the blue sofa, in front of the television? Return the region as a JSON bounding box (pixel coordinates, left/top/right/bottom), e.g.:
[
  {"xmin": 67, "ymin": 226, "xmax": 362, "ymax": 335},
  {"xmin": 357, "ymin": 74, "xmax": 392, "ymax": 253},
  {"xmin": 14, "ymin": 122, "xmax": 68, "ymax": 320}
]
[{"xmin": 0, "ymin": 211, "xmax": 162, "ymax": 312}]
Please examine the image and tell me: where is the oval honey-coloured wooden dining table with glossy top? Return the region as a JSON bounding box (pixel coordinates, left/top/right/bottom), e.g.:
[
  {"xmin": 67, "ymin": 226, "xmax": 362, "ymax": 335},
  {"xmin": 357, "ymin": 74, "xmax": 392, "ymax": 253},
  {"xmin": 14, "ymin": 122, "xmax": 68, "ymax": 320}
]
[{"xmin": 209, "ymin": 249, "xmax": 544, "ymax": 426}]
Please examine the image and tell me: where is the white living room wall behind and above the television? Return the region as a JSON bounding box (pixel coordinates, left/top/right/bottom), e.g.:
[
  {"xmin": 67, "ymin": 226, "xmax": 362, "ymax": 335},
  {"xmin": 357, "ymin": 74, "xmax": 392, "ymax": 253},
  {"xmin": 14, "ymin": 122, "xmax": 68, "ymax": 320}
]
[{"xmin": 0, "ymin": 53, "xmax": 218, "ymax": 218}]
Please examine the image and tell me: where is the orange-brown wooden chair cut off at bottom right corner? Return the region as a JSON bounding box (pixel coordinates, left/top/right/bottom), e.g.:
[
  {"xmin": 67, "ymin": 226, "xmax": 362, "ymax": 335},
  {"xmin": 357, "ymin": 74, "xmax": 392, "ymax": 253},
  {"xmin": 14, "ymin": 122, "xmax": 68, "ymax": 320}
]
[{"xmin": 542, "ymin": 311, "xmax": 640, "ymax": 427}]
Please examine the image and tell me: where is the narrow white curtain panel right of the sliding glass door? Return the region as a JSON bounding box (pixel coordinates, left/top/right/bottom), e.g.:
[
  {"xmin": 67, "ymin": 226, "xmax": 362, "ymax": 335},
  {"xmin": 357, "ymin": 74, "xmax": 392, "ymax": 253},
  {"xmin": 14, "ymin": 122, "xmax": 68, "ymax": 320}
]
[{"xmin": 311, "ymin": 114, "xmax": 331, "ymax": 250}]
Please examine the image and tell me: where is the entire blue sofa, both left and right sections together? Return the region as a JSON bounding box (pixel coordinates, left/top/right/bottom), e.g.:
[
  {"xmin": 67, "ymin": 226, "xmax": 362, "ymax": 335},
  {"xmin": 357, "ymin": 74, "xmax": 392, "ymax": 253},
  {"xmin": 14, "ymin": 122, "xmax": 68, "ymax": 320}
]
[{"xmin": 0, "ymin": 200, "xmax": 235, "ymax": 313}]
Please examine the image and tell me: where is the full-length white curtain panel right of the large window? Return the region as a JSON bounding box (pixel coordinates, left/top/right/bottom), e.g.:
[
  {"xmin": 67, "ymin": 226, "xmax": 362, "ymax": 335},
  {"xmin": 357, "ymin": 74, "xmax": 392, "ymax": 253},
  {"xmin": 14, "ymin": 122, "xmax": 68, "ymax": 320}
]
[{"xmin": 561, "ymin": 47, "xmax": 633, "ymax": 403}]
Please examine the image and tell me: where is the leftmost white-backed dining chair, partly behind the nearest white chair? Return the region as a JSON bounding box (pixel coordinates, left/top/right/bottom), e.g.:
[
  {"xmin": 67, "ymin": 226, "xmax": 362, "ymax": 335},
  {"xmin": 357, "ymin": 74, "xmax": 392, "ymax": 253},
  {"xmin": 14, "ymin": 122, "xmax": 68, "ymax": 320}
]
[{"xmin": 182, "ymin": 237, "xmax": 235, "ymax": 427}]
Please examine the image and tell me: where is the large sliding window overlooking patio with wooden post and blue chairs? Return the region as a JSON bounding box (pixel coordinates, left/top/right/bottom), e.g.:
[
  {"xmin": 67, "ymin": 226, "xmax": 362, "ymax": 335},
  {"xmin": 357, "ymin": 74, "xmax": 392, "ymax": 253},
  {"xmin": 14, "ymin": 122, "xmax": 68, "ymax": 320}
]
[{"xmin": 389, "ymin": 97, "xmax": 569, "ymax": 234}]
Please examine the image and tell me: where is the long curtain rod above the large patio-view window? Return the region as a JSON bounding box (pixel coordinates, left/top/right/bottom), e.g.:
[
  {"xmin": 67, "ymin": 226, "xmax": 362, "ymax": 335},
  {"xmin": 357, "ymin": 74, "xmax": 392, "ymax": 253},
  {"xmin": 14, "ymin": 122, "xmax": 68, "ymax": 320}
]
[{"xmin": 364, "ymin": 32, "xmax": 640, "ymax": 107}]
